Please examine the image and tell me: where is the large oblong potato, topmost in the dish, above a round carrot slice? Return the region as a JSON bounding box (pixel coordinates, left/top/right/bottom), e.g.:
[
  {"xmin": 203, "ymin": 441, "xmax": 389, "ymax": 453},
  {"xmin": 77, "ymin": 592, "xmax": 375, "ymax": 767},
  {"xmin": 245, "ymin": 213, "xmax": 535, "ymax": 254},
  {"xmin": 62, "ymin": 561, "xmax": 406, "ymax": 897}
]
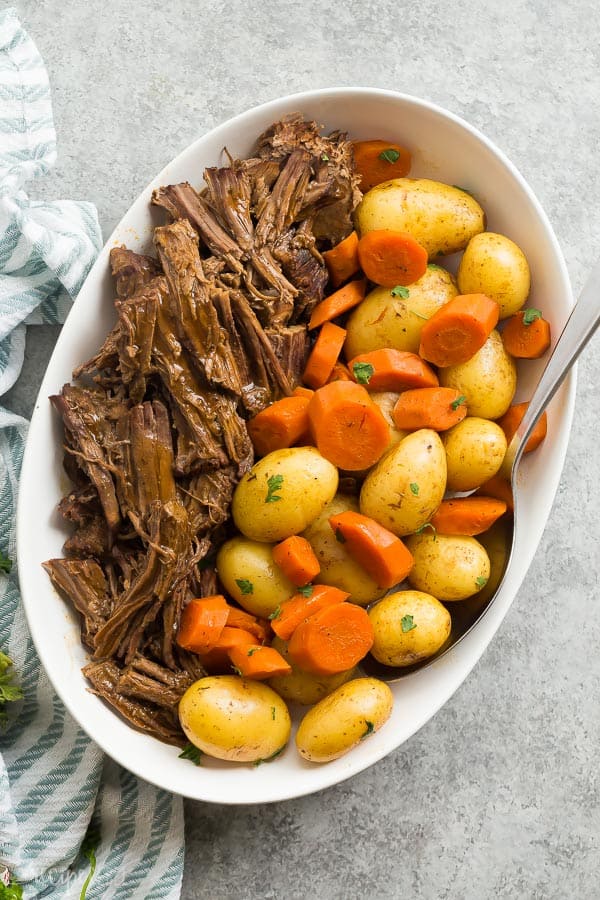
[{"xmin": 354, "ymin": 178, "xmax": 485, "ymax": 259}]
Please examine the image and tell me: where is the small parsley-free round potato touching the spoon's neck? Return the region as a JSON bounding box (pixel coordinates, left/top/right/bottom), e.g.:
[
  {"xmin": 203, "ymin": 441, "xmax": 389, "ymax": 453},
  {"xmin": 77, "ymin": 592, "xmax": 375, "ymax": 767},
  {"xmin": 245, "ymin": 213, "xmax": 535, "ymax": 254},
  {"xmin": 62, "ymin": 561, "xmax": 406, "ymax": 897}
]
[{"xmin": 441, "ymin": 416, "xmax": 506, "ymax": 491}]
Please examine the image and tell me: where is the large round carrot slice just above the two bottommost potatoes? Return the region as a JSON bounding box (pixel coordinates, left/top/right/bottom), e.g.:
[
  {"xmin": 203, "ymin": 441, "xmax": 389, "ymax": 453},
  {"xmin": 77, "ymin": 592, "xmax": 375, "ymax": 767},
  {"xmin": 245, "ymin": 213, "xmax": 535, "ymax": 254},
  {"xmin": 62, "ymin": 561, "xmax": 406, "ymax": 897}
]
[{"xmin": 288, "ymin": 603, "xmax": 373, "ymax": 675}]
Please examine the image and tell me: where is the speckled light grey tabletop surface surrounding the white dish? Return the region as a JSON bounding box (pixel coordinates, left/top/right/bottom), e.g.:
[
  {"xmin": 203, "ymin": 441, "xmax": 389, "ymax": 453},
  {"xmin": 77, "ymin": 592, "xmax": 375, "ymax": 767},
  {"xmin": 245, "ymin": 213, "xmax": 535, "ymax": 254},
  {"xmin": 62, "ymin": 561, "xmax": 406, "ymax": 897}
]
[{"xmin": 5, "ymin": 0, "xmax": 600, "ymax": 900}]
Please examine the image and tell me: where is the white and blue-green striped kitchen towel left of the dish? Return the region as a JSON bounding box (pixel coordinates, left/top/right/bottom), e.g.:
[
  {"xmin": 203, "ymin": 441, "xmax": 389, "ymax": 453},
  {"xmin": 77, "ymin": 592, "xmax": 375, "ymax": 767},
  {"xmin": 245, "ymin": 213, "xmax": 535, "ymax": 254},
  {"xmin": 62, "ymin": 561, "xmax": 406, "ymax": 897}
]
[{"xmin": 0, "ymin": 9, "xmax": 183, "ymax": 900}]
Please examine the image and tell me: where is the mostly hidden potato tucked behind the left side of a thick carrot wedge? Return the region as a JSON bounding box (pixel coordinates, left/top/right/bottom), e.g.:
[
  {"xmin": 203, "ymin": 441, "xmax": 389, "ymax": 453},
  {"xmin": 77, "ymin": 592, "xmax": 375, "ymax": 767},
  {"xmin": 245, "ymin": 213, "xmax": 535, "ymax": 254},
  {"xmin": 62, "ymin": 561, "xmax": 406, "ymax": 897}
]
[{"xmin": 303, "ymin": 494, "xmax": 385, "ymax": 606}]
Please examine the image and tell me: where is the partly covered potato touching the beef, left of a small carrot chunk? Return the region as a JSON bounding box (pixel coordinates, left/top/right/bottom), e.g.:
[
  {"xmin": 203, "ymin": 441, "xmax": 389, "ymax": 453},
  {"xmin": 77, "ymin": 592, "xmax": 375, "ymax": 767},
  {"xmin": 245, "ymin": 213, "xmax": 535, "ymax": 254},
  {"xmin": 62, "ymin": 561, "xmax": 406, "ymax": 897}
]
[{"xmin": 217, "ymin": 535, "xmax": 297, "ymax": 619}]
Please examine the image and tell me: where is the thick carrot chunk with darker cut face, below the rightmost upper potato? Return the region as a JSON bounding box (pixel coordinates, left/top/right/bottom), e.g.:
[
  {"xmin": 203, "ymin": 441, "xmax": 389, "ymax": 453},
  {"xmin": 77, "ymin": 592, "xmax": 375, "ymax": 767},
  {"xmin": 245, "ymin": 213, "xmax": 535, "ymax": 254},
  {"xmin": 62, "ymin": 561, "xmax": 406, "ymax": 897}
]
[{"xmin": 419, "ymin": 294, "xmax": 500, "ymax": 367}]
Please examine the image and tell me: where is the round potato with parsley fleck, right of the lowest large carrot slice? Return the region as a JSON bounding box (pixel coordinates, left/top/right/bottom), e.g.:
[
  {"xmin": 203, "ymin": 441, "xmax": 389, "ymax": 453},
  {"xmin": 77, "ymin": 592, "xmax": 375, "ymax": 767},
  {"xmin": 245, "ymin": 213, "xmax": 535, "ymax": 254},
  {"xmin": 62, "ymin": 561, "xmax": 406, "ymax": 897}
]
[{"xmin": 369, "ymin": 591, "xmax": 452, "ymax": 666}]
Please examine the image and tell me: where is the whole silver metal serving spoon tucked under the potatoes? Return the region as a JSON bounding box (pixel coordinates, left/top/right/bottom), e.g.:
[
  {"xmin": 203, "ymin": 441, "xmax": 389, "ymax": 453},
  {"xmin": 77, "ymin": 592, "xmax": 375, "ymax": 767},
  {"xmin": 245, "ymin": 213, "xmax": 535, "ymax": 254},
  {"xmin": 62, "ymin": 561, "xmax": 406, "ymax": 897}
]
[{"xmin": 361, "ymin": 260, "xmax": 600, "ymax": 681}]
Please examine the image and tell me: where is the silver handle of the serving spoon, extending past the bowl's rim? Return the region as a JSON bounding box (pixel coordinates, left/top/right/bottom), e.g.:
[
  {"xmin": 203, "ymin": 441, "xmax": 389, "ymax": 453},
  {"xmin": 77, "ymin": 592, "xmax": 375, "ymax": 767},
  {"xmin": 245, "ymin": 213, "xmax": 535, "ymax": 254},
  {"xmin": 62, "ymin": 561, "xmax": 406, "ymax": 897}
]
[{"xmin": 507, "ymin": 260, "xmax": 600, "ymax": 471}]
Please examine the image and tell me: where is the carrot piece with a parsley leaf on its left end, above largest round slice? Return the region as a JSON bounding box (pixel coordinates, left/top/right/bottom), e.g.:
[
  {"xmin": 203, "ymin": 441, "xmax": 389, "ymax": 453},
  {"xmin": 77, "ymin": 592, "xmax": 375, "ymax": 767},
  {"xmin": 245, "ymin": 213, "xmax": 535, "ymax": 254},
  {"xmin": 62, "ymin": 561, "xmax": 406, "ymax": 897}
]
[{"xmin": 348, "ymin": 348, "xmax": 439, "ymax": 391}]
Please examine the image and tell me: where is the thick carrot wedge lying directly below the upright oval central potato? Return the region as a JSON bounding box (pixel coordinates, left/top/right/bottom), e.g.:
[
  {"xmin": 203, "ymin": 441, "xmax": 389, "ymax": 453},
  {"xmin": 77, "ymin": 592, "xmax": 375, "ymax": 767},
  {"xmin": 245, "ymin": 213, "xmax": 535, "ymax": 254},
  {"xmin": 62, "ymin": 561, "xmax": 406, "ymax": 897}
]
[{"xmin": 329, "ymin": 510, "xmax": 413, "ymax": 588}]
